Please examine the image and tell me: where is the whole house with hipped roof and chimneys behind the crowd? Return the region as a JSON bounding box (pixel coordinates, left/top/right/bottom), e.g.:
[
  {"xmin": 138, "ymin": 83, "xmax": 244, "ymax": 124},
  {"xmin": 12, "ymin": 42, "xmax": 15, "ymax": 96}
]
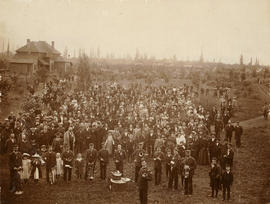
[{"xmin": 9, "ymin": 39, "xmax": 72, "ymax": 76}]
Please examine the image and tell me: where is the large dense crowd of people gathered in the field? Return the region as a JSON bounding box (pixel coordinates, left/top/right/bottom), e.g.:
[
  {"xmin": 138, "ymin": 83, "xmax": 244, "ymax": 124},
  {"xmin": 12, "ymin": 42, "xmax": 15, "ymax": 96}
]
[{"xmin": 0, "ymin": 81, "xmax": 243, "ymax": 203}]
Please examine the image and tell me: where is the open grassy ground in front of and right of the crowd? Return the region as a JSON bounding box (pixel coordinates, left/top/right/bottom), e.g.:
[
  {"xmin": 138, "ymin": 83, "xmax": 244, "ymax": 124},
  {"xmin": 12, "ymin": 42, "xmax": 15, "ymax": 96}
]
[{"xmin": 1, "ymin": 121, "xmax": 270, "ymax": 204}]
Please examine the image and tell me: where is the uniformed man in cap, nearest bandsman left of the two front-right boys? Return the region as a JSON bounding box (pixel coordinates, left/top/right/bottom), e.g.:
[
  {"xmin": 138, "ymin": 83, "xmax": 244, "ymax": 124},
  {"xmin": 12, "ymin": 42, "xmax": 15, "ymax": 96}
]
[{"xmin": 183, "ymin": 150, "xmax": 197, "ymax": 195}]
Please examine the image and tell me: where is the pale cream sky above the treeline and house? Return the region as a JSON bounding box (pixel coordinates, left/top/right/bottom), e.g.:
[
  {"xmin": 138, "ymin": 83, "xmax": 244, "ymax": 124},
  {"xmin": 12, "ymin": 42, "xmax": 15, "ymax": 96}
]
[{"xmin": 0, "ymin": 0, "xmax": 270, "ymax": 65}]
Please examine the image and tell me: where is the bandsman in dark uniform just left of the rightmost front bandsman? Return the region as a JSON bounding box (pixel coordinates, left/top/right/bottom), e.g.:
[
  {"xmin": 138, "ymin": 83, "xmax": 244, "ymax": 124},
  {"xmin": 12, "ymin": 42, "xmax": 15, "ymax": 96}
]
[{"xmin": 168, "ymin": 148, "xmax": 181, "ymax": 190}]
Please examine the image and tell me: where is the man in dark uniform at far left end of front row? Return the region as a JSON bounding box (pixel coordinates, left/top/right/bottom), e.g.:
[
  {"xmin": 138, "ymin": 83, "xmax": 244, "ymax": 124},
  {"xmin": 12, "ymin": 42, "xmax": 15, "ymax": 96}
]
[{"xmin": 9, "ymin": 145, "xmax": 23, "ymax": 195}]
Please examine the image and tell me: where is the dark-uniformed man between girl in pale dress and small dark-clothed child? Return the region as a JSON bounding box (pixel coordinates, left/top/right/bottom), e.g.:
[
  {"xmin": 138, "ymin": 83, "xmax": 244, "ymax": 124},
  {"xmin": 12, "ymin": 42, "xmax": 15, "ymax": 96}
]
[{"xmin": 62, "ymin": 145, "xmax": 74, "ymax": 182}]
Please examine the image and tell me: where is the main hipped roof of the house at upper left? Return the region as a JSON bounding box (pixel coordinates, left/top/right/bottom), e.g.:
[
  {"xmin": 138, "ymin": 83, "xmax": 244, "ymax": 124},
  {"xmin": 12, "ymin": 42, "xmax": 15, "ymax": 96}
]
[{"xmin": 16, "ymin": 41, "xmax": 61, "ymax": 55}]
